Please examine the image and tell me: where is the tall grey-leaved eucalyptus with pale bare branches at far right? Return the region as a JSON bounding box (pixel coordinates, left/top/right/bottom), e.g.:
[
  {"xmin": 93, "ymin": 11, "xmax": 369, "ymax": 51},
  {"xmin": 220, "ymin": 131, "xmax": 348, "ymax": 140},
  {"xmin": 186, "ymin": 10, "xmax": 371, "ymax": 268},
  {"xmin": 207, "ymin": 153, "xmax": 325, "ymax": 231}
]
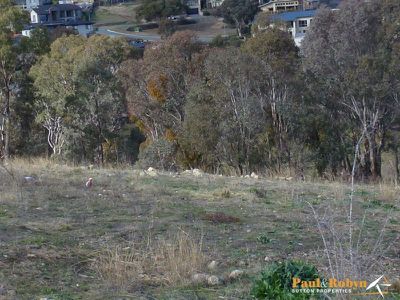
[{"xmin": 302, "ymin": 0, "xmax": 400, "ymax": 180}]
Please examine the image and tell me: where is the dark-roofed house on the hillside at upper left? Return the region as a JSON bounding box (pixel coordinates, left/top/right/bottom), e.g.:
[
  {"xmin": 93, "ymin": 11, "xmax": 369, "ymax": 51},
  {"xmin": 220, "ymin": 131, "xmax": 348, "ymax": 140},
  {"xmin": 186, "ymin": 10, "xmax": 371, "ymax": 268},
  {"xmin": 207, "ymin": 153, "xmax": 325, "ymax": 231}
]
[{"xmin": 22, "ymin": 0, "xmax": 93, "ymax": 37}]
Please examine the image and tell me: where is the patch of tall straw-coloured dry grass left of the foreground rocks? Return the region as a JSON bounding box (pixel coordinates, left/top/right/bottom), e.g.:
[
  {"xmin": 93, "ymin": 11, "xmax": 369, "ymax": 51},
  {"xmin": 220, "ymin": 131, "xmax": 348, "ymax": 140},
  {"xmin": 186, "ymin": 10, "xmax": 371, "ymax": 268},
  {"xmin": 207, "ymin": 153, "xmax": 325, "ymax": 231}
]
[{"xmin": 92, "ymin": 230, "xmax": 206, "ymax": 290}]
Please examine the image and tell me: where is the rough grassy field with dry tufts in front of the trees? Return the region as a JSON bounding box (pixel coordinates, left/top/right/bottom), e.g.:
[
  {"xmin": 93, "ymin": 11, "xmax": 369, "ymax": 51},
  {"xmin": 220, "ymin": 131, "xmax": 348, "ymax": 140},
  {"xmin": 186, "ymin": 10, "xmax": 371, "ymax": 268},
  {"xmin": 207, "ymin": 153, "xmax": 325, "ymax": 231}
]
[{"xmin": 0, "ymin": 160, "xmax": 400, "ymax": 299}]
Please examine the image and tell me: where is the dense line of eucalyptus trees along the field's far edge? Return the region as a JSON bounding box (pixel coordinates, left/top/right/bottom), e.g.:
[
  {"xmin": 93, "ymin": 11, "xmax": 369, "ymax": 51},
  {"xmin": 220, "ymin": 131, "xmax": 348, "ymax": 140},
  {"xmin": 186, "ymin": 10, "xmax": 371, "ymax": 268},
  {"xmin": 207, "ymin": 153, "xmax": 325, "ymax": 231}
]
[{"xmin": 0, "ymin": 0, "xmax": 400, "ymax": 180}]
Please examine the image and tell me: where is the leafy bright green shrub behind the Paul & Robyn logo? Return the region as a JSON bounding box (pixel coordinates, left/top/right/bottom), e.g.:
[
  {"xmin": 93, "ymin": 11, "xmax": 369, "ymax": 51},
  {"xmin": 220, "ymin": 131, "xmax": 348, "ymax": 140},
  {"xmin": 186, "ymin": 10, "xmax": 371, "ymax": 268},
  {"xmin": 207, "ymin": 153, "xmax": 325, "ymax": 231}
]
[{"xmin": 251, "ymin": 261, "xmax": 319, "ymax": 300}]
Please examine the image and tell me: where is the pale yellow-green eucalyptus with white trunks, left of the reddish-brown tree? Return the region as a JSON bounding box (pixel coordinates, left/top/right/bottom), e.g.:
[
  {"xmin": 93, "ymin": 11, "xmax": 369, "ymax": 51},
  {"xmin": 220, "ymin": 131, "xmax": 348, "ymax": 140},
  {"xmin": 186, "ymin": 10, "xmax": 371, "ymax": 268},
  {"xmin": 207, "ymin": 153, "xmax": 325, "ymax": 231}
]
[{"xmin": 31, "ymin": 35, "xmax": 133, "ymax": 163}]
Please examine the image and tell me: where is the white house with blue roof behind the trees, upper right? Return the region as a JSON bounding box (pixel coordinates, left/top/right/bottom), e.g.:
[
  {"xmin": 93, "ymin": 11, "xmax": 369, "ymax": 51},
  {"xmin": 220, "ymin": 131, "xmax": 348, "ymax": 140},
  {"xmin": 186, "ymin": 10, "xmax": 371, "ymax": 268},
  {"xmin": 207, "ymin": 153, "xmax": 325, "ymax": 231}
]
[{"xmin": 270, "ymin": 9, "xmax": 317, "ymax": 47}]
